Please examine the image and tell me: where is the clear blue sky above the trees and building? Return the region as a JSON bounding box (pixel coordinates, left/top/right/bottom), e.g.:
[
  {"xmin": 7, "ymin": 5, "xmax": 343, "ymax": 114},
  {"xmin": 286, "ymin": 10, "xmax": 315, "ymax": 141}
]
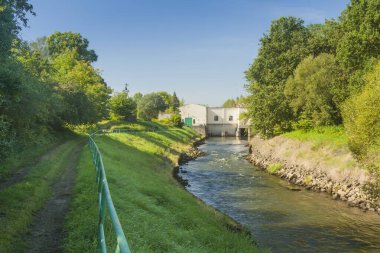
[{"xmin": 21, "ymin": 0, "xmax": 349, "ymax": 106}]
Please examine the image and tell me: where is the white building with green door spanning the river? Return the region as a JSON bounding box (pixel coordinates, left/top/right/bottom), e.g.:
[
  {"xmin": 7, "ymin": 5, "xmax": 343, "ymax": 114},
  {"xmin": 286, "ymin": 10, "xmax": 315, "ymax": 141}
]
[{"xmin": 179, "ymin": 104, "xmax": 249, "ymax": 136}]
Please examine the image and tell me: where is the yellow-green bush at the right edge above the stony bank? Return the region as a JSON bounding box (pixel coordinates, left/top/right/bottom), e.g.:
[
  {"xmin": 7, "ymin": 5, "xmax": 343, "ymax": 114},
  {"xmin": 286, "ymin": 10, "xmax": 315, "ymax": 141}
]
[{"xmin": 342, "ymin": 60, "xmax": 380, "ymax": 156}]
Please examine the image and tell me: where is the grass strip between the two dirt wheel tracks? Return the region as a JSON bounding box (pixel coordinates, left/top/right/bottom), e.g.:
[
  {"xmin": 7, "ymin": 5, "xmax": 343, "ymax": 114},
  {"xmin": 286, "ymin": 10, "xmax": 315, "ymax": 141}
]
[{"xmin": 0, "ymin": 138, "xmax": 80, "ymax": 252}]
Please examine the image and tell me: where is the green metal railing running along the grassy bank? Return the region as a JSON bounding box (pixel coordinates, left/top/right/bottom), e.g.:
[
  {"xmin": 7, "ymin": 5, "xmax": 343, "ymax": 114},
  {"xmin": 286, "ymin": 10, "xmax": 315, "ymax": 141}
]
[{"xmin": 88, "ymin": 130, "xmax": 131, "ymax": 253}]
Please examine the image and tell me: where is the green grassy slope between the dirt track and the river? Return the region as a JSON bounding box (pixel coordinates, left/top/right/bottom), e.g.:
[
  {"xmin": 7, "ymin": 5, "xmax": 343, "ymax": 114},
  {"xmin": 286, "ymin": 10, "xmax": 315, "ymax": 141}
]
[{"xmin": 65, "ymin": 122, "xmax": 257, "ymax": 252}]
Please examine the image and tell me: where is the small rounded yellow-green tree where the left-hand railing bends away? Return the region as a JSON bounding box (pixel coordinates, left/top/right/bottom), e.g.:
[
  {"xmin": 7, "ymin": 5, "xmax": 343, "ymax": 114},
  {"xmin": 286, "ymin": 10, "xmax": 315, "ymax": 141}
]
[{"xmin": 109, "ymin": 90, "xmax": 137, "ymax": 119}]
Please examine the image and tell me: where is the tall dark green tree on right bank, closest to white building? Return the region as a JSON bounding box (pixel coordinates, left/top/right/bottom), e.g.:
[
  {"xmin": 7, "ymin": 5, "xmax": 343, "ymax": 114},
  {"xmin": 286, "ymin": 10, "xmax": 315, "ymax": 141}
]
[{"xmin": 245, "ymin": 17, "xmax": 309, "ymax": 136}]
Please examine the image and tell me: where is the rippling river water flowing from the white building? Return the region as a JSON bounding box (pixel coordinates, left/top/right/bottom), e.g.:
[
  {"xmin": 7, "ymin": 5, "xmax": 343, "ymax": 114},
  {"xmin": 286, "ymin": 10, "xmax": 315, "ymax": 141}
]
[{"xmin": 180, "ymin": 138, "xmax": 380, "ymax": 252}]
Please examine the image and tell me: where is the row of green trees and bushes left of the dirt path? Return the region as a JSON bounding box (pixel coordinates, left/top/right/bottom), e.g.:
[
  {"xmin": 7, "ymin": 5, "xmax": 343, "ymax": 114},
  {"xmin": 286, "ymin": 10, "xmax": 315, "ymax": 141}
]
[{"xmin": 0, "ymin": 0, "xmax": 180, "ymax": 160}]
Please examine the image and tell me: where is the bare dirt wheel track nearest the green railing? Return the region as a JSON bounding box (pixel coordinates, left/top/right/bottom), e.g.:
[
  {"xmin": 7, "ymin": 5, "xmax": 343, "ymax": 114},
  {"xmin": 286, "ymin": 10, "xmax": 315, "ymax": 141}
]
[{"xmin": 25, "ymin": 141, "xmax": 84, "ymax": 253}]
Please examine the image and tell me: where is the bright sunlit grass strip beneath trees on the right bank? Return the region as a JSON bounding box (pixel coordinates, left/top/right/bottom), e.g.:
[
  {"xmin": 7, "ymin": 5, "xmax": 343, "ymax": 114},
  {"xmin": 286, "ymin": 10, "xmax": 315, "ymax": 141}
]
[{"xmin": 283, "ymin": 126, "xmax": 348, "ymax": 147}]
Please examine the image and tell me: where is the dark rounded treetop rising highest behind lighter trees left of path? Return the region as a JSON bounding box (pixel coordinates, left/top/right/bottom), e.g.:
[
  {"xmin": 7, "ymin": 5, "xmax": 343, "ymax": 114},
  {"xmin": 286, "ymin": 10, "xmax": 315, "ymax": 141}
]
[{"xmin": 46, "ymin": 32, "xmax": 98, "ymax": 62}]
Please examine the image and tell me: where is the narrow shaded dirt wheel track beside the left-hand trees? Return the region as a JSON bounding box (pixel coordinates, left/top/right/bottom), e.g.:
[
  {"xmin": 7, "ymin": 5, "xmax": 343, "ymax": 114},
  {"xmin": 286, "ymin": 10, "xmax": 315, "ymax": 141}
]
[{"xmin": 0, "ymin": 144, "xmax": 63, "ymax": 192}]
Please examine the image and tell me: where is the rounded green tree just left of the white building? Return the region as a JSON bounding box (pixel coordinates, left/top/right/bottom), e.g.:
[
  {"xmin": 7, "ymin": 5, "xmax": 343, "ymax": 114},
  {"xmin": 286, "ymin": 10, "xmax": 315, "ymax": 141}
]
[{"xmin": 137, "ymin": 93, "xmax": 167, "ymax": 120}]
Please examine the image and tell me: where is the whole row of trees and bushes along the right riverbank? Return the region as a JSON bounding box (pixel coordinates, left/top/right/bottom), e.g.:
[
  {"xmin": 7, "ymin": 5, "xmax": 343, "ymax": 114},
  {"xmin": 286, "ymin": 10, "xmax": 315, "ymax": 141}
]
[{"xmin": 244, "ymin": 0, "xmax": 380, "ymax": 155}]
